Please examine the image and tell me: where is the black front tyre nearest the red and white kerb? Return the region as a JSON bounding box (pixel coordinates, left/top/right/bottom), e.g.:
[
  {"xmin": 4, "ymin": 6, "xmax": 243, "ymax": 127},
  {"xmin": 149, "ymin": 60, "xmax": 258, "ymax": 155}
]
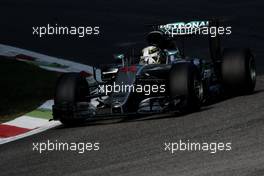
[{"xmin": 53, "ymin": 73, "xmax": 90, "ymax": 126}]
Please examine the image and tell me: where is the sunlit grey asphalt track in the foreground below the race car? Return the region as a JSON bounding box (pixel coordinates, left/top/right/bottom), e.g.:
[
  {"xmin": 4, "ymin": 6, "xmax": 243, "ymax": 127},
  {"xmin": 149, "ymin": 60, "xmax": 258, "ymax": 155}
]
[{"xmin": 0, "ymin": 76, "xmax": 264, "ymax": 176}]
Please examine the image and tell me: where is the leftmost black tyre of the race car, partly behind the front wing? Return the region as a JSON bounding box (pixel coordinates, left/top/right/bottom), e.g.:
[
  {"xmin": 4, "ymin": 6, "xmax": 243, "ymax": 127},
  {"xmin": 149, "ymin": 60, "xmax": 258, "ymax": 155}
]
[{"xmin": 54, "ymin": 73, "xmax": 90, "ymax": 126}]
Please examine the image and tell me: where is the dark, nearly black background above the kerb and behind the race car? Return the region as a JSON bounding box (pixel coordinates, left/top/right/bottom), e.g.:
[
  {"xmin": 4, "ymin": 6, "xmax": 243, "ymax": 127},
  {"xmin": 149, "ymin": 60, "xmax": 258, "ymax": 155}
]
[{"xmin": 0, "ymin": 0, "xmax": 264, "ymax": 71}]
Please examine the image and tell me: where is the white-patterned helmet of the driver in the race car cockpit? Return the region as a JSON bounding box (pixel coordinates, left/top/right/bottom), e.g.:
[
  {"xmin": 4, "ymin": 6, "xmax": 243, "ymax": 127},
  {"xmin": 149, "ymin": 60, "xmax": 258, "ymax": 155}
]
[{"xmin": 139, "ymin": 46, "xmax": 161, "ymax": 65}]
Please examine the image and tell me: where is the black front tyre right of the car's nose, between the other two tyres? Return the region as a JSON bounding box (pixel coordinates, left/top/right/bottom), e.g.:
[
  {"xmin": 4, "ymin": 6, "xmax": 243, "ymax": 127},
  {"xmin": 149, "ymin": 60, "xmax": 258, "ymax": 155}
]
[{"xmin": 169, "ymin": 62, "xmax": 203, "ymax": 113}]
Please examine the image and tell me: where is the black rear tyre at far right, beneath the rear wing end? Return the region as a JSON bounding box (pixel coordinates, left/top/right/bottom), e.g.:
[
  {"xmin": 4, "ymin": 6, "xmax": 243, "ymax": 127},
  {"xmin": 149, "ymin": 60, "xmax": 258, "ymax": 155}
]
[{"xmin": 221, "ymin": 49, "xmax": 256, "ymax": 94}]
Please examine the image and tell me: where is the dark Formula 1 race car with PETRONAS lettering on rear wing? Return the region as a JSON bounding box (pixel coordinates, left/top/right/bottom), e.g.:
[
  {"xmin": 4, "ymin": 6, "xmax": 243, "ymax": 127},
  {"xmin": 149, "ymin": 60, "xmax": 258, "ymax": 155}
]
[{"xmin": 53, "ymin": 20, "xmax": 256, "ymax": 125}]
